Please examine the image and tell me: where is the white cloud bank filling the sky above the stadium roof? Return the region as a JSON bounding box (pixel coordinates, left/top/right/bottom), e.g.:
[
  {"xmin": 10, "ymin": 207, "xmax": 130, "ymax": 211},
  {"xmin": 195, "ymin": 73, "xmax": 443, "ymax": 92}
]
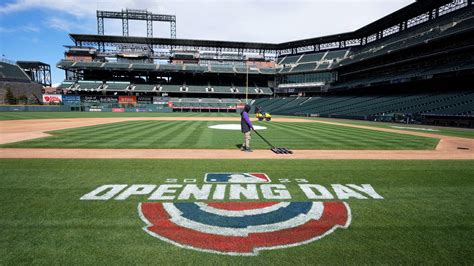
[{"xmin": 0, "ymin": 0, "xmax": 414, "ymax": 43}]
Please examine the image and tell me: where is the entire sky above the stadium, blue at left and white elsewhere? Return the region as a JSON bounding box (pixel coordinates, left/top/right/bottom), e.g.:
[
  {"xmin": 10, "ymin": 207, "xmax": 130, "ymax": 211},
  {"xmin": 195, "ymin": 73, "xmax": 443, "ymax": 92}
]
[{"xmin": 0, "ymin": 0, "xmax": 414, "ymax": 84}]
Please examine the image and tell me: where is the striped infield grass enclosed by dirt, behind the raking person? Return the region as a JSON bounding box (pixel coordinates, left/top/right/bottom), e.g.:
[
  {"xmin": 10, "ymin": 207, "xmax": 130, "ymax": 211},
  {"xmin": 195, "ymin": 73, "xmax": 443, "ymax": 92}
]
[{"xmin": 1, "ymin": 121, "xmax": 438, "ymax": 150}]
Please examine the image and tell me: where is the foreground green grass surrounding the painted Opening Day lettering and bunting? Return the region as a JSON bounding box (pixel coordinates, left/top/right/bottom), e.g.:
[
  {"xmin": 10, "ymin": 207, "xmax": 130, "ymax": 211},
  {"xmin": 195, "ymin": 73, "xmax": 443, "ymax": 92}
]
[{"xmin": 0, "ymin": 159, "xmax": 474, "ymax": 265}]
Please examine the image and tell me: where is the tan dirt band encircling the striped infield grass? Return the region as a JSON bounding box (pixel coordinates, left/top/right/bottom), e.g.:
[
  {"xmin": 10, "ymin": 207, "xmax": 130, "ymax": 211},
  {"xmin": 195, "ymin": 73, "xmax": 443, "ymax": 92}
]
[{"xmin": 0, "ymin": 117, "xmax": 474, "ymax": 160}]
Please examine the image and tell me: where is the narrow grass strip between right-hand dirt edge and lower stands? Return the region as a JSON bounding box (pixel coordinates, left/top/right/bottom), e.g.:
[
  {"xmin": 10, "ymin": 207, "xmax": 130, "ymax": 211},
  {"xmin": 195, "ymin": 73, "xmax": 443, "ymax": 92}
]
[{"xmin": 309, "ymin": 118, "xmax": 474, "ymax": 139}]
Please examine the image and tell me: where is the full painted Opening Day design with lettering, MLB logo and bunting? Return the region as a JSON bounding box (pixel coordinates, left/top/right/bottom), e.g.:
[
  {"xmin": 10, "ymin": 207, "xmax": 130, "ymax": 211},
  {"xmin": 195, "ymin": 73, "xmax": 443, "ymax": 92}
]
[{"xmin": 80, "ymin": 173, "xmax": 383, "ymax": 256}]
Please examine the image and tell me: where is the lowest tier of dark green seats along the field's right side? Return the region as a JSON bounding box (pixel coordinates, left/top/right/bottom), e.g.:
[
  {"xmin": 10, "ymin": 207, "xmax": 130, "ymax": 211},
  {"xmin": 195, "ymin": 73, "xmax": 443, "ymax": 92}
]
[{"xmin": 253, "ymin": 91, "xmax": 474, "ymax": 119}]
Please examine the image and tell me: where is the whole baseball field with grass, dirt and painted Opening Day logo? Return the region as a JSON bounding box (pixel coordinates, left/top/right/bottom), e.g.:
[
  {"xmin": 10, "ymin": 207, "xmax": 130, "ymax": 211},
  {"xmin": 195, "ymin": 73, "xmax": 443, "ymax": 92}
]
[{"xmin": 0, "ymin": 113, "xmax": 474, "ymax": 265}]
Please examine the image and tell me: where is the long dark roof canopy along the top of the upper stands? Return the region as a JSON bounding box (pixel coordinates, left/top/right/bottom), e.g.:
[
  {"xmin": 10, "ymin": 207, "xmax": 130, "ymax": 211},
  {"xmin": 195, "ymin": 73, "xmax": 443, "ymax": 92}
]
[{"xmin": 69, "ymin": 0, "xmax": 454, "ymax": 54}]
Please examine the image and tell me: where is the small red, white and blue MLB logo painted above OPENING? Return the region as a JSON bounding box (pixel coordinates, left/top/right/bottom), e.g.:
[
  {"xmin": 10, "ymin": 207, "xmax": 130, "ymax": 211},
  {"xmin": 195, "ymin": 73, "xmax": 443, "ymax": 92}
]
[{"xmin": 204, "ymin": 173, "xmax": 271, "ymax": 183}]
